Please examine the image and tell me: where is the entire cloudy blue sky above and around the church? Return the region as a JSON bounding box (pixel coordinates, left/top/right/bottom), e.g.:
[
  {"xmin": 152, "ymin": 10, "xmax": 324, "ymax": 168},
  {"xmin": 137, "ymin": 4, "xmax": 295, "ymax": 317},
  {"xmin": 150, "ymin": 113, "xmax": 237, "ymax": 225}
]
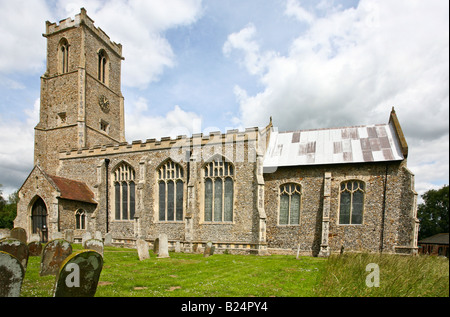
[{"xmin": 0, "ymin": 0, "xmax": 449, "ymax": 196}]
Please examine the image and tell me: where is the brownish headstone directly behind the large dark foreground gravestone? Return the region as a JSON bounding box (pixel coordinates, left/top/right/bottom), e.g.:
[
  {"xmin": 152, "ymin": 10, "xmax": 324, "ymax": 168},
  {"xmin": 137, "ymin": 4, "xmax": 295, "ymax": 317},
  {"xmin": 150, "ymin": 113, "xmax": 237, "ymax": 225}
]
[{"xmin": 39, "ymin": 239, "xmax": 72, "ymax": 276}]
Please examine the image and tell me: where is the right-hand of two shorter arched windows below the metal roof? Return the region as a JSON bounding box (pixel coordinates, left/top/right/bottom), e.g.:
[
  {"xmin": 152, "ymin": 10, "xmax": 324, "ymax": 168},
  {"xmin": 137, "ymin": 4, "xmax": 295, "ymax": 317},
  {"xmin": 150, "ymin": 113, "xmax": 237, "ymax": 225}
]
[{"xmin": 339, "ymin": 180, "xmax": 365, "ymax": 225}]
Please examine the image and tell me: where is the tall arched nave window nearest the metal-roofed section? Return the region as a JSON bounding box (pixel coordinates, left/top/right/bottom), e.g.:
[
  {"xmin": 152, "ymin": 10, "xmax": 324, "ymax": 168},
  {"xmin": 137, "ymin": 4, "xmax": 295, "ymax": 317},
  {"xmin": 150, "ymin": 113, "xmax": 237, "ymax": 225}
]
[{"xmin": 204, "ymin": 158, "xmax": 234, "ymax": 222}]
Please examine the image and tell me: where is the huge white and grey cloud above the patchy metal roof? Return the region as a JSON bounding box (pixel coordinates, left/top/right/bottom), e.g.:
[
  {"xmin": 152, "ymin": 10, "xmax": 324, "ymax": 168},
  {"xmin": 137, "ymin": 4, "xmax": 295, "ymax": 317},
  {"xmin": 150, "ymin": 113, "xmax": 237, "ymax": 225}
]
[{"xmin": 224, "ymin": 0, "xmax": 449, "ymax": 138}]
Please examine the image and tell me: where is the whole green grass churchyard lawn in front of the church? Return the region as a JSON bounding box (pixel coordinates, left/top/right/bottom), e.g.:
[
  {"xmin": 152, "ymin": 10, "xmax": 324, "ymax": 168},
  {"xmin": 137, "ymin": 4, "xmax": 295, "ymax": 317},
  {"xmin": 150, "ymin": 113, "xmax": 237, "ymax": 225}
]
[{"xmin": 21, "ymin": 244, "xmax": 449, "ymax": 297}]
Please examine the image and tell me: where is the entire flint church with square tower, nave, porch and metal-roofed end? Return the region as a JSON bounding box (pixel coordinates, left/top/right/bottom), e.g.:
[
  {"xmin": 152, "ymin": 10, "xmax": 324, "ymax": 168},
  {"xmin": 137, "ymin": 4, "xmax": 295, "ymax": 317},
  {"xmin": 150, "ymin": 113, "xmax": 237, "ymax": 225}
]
[{"xmin": 14, "ymin": 8, "xmax": 419, "ymax": 256}]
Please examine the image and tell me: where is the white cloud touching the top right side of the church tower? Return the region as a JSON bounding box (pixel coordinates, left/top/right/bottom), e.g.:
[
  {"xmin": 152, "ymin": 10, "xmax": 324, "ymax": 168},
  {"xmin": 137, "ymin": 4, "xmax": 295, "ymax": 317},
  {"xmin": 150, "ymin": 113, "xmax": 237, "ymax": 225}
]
[{"xmin": 57, "ymin": 0, "xmax": 202, "ymax": 88}]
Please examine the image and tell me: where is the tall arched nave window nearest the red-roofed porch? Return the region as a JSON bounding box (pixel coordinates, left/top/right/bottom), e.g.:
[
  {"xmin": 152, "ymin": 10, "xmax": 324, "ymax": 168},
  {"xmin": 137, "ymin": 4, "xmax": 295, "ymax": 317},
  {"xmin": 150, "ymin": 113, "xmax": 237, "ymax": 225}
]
[{"xmin": 113, "ymin": 163, "xmax": 136, "ymax": 220}]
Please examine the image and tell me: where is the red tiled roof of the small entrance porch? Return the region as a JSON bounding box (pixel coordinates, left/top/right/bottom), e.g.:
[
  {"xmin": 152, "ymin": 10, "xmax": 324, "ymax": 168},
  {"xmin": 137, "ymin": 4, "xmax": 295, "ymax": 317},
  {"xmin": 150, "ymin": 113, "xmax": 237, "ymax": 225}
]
[{"xmin": 48, "ymin": 175, "xmax": 97, "ymax": 204}]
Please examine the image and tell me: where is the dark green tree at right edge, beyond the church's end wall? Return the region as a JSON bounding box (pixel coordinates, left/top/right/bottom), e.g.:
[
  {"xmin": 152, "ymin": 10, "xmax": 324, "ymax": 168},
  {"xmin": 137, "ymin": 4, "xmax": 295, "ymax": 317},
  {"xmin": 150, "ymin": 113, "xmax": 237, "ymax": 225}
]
[{"xmin": 417, "ymin": 185, "xmax": 449, "ymax": 240}]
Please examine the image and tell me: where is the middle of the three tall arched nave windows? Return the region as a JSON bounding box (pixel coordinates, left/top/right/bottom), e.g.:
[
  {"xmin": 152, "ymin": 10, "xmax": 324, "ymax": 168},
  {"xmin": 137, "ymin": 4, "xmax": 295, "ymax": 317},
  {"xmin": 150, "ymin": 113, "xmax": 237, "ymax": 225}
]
[{"xmin": 158, "ymin": 160, "xmax": 184, "ymax": 221}]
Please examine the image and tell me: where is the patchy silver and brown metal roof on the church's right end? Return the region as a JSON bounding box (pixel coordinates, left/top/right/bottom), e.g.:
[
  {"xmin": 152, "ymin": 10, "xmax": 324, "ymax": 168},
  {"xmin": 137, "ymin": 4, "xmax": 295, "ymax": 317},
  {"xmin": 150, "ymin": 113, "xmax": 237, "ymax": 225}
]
[{"xmin": 264, "ymin": 120, "xmax": 404, "ymax": 167}]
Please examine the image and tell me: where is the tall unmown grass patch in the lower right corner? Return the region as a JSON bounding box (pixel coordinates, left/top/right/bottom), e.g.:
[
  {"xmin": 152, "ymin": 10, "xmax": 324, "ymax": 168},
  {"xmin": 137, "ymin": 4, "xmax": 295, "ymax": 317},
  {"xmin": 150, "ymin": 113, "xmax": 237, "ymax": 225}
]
[{"xmin": 316, "ymin": 253, "xmax": 449, "ymax": 297}]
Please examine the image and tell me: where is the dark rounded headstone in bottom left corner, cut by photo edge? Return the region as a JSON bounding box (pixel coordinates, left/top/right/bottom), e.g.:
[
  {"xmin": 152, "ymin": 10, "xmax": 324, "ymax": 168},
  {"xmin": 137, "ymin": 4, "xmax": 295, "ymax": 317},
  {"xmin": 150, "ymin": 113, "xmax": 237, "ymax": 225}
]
[{"xmin": 0, "ymin": 251, "xmax": 25, "ymax": 297}]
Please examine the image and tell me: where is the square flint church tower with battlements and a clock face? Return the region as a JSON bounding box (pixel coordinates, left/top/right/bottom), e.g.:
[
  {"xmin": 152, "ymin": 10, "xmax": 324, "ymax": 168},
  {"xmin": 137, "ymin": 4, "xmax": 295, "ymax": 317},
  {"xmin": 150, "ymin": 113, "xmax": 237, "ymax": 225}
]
[{"xmin": 34, "ymin": 9, "xmax": 125, "ymax": 174}]
